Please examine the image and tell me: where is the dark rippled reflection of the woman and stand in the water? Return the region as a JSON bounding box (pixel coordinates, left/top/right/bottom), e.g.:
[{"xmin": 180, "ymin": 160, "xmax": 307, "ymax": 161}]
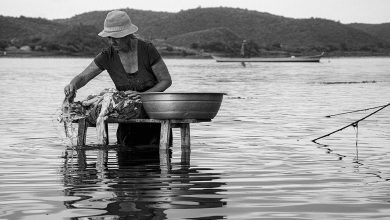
[{"xmin": 63, "ymin": 146, "xmax": 226, "ymax": 219}]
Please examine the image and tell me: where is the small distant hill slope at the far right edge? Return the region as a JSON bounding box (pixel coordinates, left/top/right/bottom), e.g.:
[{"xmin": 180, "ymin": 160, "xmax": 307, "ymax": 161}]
[{"xmin": 348, "ymin": 23, "xmax": 390, "ymax": 43}]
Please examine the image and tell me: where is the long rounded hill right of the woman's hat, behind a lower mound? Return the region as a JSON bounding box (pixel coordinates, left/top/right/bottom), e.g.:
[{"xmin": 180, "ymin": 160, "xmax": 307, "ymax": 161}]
[{"xmin": 145, "ymin": 8, "xmax": 381, "ymax": 48}]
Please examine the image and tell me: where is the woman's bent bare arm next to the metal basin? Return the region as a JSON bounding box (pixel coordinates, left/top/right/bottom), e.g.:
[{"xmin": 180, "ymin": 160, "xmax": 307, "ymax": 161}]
[{"xmin": 146, "ymin": 59, "xmax": 172, "ymax": 92}]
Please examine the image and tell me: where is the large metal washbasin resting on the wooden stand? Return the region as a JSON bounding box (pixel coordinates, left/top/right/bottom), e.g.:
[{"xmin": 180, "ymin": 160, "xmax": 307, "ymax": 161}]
[{"xmin": 141, "ymin": 92, "xmax": 224, "ymax": 119}]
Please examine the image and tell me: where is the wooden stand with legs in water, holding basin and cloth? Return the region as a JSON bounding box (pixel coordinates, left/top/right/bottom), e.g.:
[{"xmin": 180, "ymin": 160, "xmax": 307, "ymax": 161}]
[{"xmin": 77, "ymin": 118, "xmax": 211, "ymax": 151}]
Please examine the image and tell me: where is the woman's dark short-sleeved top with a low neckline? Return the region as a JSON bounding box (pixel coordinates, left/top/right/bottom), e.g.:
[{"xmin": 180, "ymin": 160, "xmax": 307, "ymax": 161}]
[{"xmin": 94, "ymin": 39, "xmax": 161, "ymax": 92}]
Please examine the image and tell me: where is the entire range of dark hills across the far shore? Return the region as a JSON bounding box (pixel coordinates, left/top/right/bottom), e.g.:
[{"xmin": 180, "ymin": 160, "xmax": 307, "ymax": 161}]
[{"xmin": 0, "ymin": 7, "xmax": 390, "ymax": 55}]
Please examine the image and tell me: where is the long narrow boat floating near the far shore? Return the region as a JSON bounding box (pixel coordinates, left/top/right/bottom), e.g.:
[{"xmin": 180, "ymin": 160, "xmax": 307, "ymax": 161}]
[{"xmin": 213, "ymin": 53, "xmax": 324, "ymax": 63}]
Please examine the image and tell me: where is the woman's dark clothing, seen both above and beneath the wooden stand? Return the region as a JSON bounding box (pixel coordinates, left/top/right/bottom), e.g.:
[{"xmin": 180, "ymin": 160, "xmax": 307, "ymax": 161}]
[{"xmin": 94, "ymin": 39, "xmax": 161, "ymax": 146}]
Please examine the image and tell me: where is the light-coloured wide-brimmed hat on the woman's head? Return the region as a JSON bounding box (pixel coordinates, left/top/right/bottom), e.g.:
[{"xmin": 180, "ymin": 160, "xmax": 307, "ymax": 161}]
[{"xmin": 99, "ymin": 11, "xmax": 138, "ymax": 38}]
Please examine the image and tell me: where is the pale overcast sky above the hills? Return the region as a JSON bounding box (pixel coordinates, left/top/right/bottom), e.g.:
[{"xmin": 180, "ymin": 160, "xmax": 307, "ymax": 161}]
[{"xmin": 0, "ymin": 0, "xmax": 390, "ymax": 23}]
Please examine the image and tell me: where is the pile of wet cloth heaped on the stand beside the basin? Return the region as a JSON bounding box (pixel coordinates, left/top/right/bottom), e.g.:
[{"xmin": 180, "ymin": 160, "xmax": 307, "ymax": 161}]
[{"xmin": 60, "ymin": 88, "xmax": 147, "ymax": 143}]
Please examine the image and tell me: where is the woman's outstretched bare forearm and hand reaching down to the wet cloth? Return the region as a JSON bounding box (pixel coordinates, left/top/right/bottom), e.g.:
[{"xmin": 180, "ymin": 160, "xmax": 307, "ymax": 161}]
[{"xmin": 64, "ymin": 61, "xmax": 103, "ymax": 97}]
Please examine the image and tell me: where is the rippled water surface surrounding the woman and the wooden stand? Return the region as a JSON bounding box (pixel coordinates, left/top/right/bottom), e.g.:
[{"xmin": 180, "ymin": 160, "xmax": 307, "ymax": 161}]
[{"xmin": 0, "ymin": 58, "xmax": 390, "ymax": 219}]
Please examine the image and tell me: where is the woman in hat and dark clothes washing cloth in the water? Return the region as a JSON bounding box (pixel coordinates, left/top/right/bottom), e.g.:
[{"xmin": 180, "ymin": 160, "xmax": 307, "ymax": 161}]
[{"xmin": 64, "ymin": 11, "xmax": 172, "ymax": 145}]
